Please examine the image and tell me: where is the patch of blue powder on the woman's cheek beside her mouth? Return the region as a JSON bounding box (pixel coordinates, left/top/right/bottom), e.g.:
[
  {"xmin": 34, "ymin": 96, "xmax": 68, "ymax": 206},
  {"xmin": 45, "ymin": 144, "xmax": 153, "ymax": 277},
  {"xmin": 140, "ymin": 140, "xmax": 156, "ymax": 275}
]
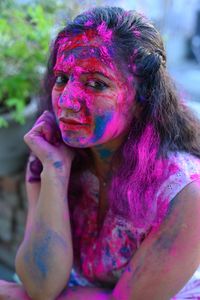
[{"xmin": 92, "ymin": 113, "xmax": 112, "ymax": 142}]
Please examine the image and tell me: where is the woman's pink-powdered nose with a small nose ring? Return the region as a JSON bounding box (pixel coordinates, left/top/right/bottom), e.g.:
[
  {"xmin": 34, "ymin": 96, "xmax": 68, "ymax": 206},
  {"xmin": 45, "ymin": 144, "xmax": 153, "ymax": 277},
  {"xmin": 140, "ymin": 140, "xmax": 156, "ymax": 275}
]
[{"xmin": 58, "ymin": 84, "xmax": 81, "ymax": 112}]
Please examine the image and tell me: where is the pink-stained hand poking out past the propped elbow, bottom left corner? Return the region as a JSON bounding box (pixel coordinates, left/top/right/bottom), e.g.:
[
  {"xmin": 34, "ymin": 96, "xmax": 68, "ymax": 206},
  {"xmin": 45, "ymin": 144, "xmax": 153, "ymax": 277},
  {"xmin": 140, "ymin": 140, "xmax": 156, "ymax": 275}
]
[{"xmin": 0, "ymin": 280, "xmax": 30, "ymax": 300}]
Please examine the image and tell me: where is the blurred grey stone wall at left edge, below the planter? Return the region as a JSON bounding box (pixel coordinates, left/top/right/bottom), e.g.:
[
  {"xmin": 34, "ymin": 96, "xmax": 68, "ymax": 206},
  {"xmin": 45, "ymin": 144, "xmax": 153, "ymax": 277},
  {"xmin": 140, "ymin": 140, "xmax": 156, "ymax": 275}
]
[{"xmin": 0, "ymin": 173, "xmax": 27, "ymax": 279}]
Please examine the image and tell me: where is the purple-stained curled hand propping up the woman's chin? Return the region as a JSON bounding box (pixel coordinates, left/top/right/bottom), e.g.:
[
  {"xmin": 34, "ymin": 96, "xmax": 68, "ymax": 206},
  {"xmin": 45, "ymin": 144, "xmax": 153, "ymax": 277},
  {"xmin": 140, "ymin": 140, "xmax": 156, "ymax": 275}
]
[{"xmin": 24, "ymin": 111, "xmax": 74, "ymax": 173}]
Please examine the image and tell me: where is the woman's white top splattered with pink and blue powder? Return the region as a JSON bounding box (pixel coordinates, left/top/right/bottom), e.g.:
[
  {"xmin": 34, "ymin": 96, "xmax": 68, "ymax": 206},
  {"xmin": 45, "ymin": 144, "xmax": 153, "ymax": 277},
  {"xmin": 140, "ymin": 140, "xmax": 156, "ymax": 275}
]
[{"xmin": 68, "ymin": 152, "xmax": 200, "ymax": 299}]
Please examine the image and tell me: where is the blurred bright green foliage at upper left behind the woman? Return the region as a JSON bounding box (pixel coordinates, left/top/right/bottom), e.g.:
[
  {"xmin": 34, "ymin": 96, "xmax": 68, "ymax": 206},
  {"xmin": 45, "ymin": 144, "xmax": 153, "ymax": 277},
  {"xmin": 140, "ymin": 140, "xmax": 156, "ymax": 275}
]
[{"xmin": 0, "ymin": 0, "xmax": 56, "ymax": 127}]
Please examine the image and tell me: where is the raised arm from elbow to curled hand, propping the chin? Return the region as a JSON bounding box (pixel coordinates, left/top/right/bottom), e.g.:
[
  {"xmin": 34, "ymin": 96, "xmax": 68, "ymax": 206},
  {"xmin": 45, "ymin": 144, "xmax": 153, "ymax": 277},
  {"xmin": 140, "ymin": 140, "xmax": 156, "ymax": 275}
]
[{"xmin": 16, "ymin": 112, "xmax": 73, "ymax": 300}]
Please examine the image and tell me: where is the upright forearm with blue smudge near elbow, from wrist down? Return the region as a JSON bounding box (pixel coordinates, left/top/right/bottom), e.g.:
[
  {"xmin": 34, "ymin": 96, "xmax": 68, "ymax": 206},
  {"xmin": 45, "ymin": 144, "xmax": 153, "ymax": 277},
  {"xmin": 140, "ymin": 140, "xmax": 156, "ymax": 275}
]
[{"xmin": 16, "ymin": 167, "xmax": 73, "ymax": 300}]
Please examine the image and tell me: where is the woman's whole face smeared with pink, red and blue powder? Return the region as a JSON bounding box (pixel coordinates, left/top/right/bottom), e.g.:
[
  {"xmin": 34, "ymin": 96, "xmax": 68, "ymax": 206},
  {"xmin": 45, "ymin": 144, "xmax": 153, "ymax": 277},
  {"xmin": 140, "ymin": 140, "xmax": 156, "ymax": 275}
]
[{"xmin": 52, "ymin": 31, "xmax": 135, "ymax": 148}]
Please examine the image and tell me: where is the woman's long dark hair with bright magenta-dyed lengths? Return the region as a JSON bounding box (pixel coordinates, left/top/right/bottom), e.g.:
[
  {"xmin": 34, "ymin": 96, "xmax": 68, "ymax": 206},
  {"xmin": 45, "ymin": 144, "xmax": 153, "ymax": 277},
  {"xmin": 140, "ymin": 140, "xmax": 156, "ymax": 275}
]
[{"xmin": 40, "ymin": 7, "xmax": 200, "ymax": 228}]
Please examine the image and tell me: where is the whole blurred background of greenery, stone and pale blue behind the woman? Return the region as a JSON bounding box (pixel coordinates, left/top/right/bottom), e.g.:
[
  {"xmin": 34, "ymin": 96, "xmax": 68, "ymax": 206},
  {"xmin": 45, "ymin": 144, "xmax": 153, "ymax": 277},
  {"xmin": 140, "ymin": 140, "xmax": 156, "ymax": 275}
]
[{"xmin": 0, "ymin": 0, "xmax": 200, "ymax": 281}]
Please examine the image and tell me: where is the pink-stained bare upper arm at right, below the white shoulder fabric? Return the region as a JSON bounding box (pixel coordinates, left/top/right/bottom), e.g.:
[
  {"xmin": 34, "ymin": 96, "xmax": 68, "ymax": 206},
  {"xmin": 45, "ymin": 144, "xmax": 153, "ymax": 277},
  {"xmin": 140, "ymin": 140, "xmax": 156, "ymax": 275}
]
[{"xmin": 113, "ymin": 181, "xmax": 200, "ymax": 300}]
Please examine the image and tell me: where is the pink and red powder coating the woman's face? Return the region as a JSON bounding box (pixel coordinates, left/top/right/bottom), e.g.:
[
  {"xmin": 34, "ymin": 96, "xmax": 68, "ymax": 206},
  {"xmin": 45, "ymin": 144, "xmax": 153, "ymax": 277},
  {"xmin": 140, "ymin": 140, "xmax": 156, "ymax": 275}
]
[{"xmin": 52, "ymin": 28, "xmax": 136, "ymax": 145}]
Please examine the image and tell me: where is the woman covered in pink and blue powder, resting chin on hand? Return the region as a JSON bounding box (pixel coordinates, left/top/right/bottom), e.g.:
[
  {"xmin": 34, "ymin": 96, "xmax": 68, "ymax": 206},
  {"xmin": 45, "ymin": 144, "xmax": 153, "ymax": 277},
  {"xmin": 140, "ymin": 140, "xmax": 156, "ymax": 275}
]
[{"xmin": 1, "ymin": 7, "xmax": 200, "ymax": 300}]
